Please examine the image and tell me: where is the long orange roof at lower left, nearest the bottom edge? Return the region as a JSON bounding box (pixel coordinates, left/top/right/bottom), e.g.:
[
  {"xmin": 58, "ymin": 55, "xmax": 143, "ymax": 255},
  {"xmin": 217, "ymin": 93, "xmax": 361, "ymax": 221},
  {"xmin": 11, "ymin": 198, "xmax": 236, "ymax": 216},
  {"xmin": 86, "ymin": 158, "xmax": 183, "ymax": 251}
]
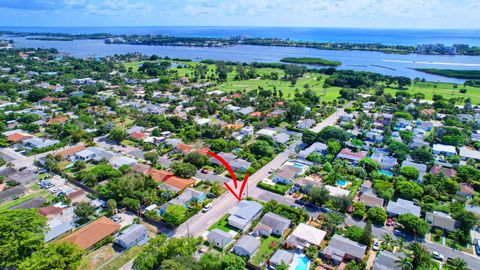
[{"xmin": 62, "ymin": 217, "xmax": 120, "ymax": 249}]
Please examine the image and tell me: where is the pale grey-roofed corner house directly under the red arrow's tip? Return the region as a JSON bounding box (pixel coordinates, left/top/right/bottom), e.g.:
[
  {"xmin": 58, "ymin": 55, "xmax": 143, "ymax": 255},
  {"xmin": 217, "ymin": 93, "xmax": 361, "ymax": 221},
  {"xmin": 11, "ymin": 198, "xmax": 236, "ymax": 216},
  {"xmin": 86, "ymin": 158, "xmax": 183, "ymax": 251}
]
[{"xmin": 228, "ymin": 200, "xmax": 262, "ymax": 230}]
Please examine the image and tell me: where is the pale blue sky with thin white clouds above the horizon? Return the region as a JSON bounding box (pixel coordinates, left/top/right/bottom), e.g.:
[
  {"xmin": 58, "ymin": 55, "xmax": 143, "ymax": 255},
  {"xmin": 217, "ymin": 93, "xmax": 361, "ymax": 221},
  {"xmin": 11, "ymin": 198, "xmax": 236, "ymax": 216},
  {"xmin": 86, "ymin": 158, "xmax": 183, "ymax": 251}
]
[{"xmin": 0, "ymin": 0, "xmax": 480, "ymax": 29}]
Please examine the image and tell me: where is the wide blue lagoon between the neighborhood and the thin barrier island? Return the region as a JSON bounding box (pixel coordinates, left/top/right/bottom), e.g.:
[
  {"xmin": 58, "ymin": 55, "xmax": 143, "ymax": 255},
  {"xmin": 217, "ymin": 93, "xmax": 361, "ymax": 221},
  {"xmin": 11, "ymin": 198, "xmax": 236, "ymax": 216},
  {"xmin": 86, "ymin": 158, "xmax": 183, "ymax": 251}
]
[{"xmin": 0, "ymin": 33, "xmax": 480, "ymax": 83}]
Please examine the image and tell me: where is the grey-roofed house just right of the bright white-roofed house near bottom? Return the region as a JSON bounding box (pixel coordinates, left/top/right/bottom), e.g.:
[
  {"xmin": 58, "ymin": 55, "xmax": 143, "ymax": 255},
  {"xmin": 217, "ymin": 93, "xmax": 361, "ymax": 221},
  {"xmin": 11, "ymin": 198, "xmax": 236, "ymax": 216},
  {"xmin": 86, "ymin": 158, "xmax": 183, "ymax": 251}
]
[{"xmin": 323, "ymin": 234, "xmax": 367, "ymax": 263}]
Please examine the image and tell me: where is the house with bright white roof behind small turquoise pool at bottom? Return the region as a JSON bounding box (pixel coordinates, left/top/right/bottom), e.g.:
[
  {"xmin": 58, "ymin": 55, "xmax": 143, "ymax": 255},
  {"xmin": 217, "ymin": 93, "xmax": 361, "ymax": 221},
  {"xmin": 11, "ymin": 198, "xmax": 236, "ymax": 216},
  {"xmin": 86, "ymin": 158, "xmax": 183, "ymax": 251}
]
[{"xmin": 286, "ymin": 223, "xmax": 327, "ymax": 249}]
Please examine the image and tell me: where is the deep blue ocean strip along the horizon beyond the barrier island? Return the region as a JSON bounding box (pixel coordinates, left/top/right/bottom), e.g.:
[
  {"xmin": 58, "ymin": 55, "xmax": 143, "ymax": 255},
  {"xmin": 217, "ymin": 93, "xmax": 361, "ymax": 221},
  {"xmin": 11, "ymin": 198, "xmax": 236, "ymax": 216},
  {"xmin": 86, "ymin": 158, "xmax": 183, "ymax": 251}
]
[{"xmin": 0, "ymin": 26, "xmax": 480, "ymax": 45}]
